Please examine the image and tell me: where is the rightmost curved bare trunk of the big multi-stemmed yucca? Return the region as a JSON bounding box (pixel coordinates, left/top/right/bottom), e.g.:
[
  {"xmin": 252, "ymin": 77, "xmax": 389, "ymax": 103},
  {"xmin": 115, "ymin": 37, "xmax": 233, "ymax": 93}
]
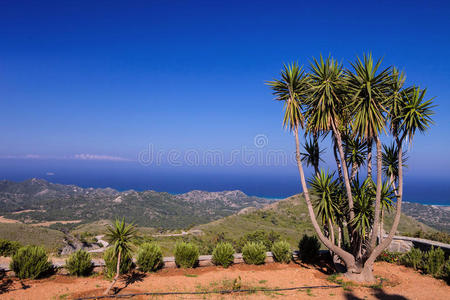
[{"xmin": 364, "ymin": 138, "xmax": 403, "ymax": 276}]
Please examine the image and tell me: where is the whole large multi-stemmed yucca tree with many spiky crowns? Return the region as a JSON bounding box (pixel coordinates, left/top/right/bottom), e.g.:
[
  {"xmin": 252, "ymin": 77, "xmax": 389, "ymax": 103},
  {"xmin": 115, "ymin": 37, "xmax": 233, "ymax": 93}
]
[{"xmin": 269, "ymin": 55, "xmax": 433, "ymax": 281}]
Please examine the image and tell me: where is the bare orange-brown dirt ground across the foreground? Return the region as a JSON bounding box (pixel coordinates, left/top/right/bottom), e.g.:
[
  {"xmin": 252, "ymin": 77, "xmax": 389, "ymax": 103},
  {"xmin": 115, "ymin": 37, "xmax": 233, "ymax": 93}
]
[{"xmin": 0, "ymin": 263, "xmax": 450, "ymax": 300}]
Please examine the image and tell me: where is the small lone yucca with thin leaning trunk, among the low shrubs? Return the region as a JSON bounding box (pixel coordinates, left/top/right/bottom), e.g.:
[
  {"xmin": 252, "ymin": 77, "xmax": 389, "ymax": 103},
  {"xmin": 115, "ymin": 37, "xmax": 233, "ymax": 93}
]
[{"xmin": 104, "ymin": 219, "xmax": 137, "ymax": 295}]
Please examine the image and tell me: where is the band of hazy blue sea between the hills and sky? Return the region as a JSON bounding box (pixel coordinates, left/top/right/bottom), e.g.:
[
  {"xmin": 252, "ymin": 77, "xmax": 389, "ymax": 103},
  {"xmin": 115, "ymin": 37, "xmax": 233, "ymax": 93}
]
[{"xmin": 0, "ymin": 159, "xmax": 450, "ymax": 205}]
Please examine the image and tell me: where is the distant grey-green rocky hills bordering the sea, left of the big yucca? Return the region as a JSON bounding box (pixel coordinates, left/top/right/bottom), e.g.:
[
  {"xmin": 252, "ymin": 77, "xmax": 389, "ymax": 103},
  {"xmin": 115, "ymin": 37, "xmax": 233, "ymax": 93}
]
[{"xmin": 0, "ymin": 179, "xmax": 270, "ymax": 228}]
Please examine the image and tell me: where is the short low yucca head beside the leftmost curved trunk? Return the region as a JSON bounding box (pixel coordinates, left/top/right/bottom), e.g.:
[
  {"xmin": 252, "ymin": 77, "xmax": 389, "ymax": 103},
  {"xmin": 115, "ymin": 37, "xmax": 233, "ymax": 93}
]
[{"xmin": 308, "ymin": 170, "xmax": 341, "ymax": 243}]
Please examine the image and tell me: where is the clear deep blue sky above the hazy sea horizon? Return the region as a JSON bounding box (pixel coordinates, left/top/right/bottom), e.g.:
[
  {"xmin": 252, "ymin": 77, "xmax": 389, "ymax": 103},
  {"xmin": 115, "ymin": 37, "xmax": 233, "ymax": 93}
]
[{"xmin": 0, "ymin": 0, "xmax": 450, "ymax": 198}]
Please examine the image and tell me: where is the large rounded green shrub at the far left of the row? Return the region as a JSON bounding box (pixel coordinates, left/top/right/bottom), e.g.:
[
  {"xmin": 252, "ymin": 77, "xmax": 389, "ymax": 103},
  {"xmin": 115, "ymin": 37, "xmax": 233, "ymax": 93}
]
[{"xmin": 10, "ymin": 246, "xmax": 52, "ymax": 279}]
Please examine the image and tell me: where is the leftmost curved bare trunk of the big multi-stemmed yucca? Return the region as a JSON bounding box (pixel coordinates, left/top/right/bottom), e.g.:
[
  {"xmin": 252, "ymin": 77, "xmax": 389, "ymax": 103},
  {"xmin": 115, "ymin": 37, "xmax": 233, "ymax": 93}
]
[{"xmin": 294, "ymin": 127, "xmax": 358, "ymax": 272}]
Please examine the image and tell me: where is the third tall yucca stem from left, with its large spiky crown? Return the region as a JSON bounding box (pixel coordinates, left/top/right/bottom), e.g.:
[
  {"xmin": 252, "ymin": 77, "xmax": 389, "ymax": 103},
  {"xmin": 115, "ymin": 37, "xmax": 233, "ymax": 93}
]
[{"xmin": 346, "ymin": 54, "xmax": 392, "ymax": 253}]
